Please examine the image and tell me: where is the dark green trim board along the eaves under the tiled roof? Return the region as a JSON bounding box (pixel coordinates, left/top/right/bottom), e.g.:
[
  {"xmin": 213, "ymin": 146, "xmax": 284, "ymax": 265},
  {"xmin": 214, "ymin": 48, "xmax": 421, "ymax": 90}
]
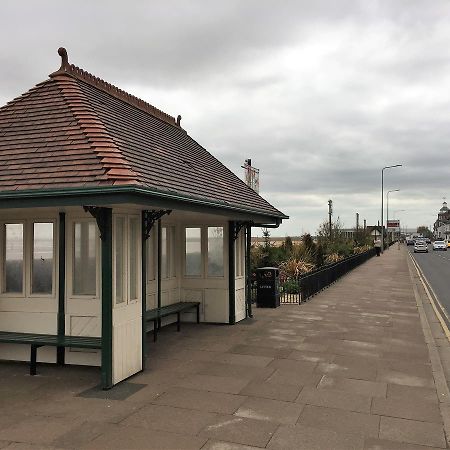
[{"xmin": 0, "ymin": 186, "xmax": 288, "ymax": 225}]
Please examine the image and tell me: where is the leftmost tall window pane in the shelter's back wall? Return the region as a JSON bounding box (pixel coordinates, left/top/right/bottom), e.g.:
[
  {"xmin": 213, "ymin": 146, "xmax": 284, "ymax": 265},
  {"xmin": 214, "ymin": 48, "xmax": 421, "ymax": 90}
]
[{"xmin": 4, "ymin": 223, "xmax": 23, "ymax": 293}]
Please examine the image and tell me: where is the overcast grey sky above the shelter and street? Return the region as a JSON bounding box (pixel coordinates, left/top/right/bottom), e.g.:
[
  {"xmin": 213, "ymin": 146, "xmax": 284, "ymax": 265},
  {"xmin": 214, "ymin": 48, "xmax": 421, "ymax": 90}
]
[{"xmin": 0, "ymin": 0, "xmax": 450, "ymax": 236}]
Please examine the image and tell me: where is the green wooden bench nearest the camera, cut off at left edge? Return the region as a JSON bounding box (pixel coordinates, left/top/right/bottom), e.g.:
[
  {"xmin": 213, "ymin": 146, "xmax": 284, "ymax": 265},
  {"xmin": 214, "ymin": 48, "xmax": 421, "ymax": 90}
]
[{"xmin": 0, "ymin": 331, "xmax": 102, "ymax": 375}]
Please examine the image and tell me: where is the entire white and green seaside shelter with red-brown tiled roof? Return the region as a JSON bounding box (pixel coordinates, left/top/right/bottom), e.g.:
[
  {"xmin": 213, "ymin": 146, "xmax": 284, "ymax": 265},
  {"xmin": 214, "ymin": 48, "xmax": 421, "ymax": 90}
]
[{"xmin": 0, "ymin": 48, "xmax": 287, "ymax": 389}]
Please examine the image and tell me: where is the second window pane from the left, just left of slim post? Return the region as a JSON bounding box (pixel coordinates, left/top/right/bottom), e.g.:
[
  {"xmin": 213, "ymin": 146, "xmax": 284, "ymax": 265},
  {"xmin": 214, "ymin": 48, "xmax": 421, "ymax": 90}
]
[{"xmin": 31, "ymin": 223, "xmax": 53, "ymax": 294}]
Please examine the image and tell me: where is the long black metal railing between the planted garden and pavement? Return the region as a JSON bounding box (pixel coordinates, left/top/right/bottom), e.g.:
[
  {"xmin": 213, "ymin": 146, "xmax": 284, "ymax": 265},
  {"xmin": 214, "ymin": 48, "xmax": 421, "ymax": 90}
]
[{"xmin": 251, "ymin": 248, "xmax": 376, "ymax": 304}]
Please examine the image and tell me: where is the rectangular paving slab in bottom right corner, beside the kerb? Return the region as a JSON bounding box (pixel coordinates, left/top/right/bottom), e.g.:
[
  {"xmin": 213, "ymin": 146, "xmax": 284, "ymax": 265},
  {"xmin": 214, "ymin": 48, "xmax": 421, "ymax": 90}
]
[{"xmin": 379, "ymin": 417, "xmax": 447, "ymax": 448}]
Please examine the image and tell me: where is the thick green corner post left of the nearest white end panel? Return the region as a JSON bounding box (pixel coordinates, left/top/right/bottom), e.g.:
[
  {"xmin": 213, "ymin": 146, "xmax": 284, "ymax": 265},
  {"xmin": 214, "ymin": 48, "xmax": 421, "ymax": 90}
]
[{"xmin": 100, "ymin": 208, "xmax": 113, "ymax": 389}]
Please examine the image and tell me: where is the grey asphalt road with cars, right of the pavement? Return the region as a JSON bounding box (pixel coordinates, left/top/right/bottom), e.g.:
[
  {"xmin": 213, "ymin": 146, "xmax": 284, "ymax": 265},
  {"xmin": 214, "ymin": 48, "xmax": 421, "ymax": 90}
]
[{"xmin": 408, "ymin": 245, "xmax": 450, "ymax": 315}]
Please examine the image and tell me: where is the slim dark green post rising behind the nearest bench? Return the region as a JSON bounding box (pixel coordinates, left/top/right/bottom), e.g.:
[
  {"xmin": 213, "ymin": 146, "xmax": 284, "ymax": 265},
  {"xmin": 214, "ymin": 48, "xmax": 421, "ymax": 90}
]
[{"xmin": 56, "ymin": 212, "xmax": 66, "ymax": 366}]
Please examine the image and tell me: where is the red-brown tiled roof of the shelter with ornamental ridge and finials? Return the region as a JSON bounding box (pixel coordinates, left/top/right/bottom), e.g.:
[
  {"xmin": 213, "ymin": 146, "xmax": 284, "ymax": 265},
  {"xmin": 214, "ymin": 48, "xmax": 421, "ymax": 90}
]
[{"xmin": 0, "ymin": 49, "xmax": 283, "ymax": 217}]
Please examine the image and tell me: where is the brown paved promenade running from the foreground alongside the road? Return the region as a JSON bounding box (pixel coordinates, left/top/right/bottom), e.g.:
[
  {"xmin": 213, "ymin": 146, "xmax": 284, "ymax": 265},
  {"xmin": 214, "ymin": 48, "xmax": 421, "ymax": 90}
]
[{"xmin": 0, "ymin": 248, "xmax": 449, "ymax": 450}]
